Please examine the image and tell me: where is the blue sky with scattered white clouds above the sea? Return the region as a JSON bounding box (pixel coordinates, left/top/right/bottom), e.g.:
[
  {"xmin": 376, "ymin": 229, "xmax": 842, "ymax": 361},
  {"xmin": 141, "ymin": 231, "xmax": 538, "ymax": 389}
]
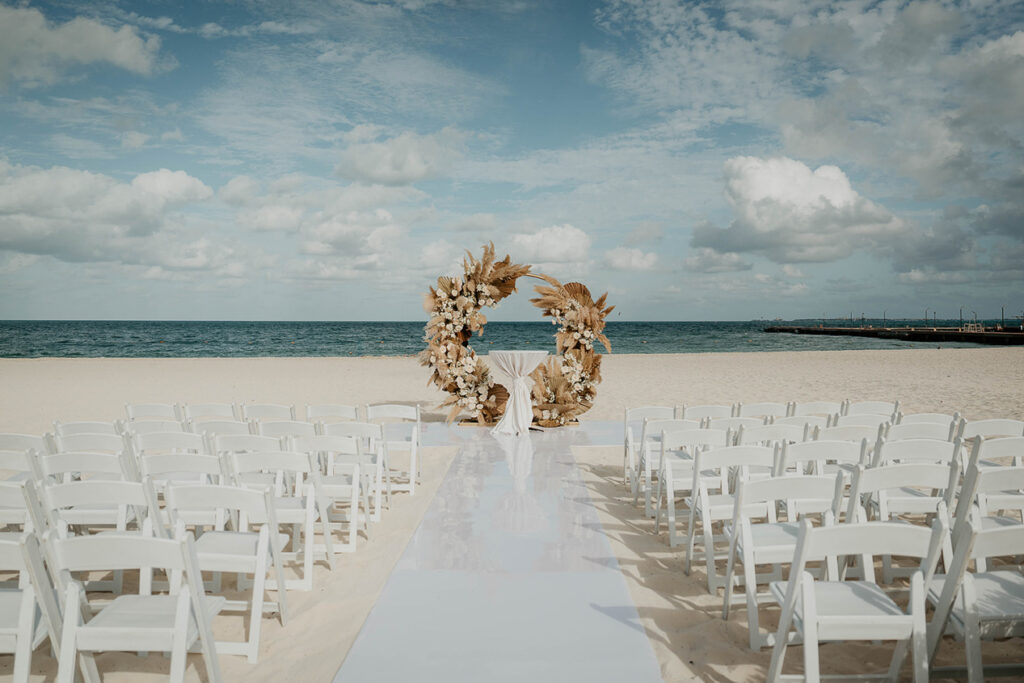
[{"xmin": 0, "ymin": 0, "xmax": 1024, "ymax": 321}]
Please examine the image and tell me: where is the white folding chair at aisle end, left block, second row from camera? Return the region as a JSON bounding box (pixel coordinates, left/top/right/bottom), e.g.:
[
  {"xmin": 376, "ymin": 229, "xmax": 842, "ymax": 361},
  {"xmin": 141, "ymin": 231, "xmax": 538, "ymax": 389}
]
[{"xmin": 167, "ymin": 484, "xmax": 288, "ymax": 664}]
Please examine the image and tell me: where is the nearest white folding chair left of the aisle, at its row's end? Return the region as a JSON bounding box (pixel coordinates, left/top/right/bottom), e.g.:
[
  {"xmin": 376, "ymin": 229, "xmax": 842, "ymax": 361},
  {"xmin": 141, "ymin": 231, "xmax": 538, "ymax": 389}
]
[{"xmin": 46, "ymin": 535, "xmax": 224, "ymax": 683}]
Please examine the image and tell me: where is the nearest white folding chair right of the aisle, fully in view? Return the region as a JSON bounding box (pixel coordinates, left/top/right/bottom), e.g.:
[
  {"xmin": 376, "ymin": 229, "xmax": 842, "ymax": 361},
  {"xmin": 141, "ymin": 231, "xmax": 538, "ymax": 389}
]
[{"xmin": 767, "ymin": 518, "xmax": 947, "ymax": 683}]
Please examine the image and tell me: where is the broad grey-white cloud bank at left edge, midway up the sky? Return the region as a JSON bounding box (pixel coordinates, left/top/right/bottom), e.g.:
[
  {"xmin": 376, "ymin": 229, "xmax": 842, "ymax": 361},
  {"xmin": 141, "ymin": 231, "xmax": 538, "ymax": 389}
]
[{"xmin": 0, "ymin": 161, "xmax": 212, "ymax": 261}]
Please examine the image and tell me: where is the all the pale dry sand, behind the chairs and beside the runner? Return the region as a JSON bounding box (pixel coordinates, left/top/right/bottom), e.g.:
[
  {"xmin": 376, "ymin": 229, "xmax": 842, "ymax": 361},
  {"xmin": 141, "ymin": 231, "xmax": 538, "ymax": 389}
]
[{"xmin": 0, "ymin": 348, "xmax": 1024, "ymax": 683}]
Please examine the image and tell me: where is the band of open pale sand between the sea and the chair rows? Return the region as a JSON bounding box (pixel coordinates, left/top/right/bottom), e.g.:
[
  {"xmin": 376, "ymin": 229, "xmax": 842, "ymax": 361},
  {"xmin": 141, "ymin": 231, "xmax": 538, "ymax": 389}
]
[{"xmin": 0, "ymin": 347, "xmax": 1024, "ymax": 433}]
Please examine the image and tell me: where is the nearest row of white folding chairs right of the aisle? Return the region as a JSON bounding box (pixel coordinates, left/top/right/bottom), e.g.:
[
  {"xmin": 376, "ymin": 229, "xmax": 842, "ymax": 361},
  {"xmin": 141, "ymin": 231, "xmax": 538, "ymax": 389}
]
[{"xmin": 768, "ymin": 497, "xmax": 1024, "ymax": 683}]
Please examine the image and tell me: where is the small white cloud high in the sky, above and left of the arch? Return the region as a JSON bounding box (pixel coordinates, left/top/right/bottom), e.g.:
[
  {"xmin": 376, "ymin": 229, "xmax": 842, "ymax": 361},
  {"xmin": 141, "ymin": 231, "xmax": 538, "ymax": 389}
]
[{"xmin": 335, "ymin": 128, "xmax": 465, "ymax": 185}]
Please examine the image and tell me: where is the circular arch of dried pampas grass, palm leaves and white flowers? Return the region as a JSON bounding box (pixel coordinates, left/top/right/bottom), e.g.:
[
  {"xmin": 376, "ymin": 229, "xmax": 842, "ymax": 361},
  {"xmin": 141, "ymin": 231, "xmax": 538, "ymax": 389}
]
[{"xmin": 420, "ymin": 243, "xmax": 614, "ymax": 427}]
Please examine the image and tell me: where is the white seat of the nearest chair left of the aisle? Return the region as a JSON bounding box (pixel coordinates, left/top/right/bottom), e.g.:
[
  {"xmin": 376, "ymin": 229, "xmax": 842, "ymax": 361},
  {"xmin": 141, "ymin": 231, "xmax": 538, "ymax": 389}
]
[{"xmin": 78, "ymin": 595, "xmax": 225, "ymax": 650}]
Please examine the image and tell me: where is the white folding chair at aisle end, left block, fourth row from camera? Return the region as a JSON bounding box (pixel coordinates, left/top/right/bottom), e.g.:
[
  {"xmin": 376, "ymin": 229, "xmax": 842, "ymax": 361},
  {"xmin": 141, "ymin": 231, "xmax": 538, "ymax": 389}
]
[{"xmin": 289, "ymin": 434, "xmax": 370, "ymax": 552}]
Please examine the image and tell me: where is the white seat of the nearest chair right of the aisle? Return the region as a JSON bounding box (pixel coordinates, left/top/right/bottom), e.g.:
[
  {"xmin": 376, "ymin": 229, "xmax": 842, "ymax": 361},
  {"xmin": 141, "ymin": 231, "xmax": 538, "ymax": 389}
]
[{"xmin": 769, "ymin": 581, "xmax": 912, "ymax": 640}]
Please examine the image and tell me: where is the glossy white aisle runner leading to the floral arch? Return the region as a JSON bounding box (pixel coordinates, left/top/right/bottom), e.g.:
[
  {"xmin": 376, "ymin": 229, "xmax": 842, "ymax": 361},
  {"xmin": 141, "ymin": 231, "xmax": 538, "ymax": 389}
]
[{"xmin": 335, "ymin": 423, "xmax": 662, "ymax": 683}]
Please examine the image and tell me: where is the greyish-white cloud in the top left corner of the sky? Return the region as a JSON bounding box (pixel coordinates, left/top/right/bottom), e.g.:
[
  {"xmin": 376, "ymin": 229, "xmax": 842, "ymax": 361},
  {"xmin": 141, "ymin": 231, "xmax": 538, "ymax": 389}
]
[{"xmin": 0, "ymin": 5, "xmax": 160, "ymax": 85}]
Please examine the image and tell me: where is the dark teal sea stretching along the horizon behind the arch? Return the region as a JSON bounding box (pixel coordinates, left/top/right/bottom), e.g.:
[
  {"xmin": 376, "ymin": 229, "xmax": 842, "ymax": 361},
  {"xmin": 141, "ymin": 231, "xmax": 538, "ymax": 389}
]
[{"xmin": 0, "ymin": 319, "xmax": 995, "ymax": 358}]
